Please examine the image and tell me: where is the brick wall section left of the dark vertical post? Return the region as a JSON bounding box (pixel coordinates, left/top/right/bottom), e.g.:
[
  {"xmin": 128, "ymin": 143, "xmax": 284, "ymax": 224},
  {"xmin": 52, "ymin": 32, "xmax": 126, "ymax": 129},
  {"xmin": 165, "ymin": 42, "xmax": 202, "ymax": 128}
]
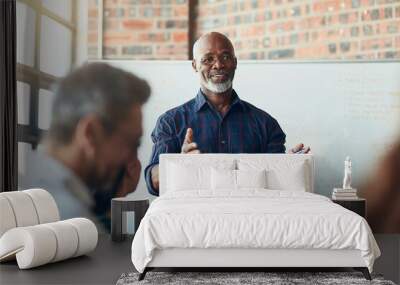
[{"xmin": 88, "ymin": 0, "xmax": 189, "ymax": 59}]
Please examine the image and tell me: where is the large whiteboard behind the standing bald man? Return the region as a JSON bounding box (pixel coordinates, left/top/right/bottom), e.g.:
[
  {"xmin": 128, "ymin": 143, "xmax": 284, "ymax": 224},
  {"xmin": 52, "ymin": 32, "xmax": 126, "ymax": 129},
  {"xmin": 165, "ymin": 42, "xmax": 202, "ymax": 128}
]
[{"xmin": 105, "ymin": 61, "xmax": 400, "ymax": 197}]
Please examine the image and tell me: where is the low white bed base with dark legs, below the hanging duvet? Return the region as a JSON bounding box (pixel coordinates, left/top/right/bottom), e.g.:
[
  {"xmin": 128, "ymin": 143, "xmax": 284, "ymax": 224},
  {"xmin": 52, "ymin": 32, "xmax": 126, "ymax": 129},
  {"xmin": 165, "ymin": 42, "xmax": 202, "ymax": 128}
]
[{"xmin": 139, "ymin": 248, "xmax": 371, "ymax": 280}]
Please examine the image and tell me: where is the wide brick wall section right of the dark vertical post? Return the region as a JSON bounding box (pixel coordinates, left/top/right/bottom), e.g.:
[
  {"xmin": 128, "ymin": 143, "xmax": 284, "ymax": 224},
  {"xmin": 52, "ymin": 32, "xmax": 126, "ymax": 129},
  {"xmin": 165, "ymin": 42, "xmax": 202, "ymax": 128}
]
[{"xmin": 197, "ymin": 0, "xmax": 400, "ymax": 59}]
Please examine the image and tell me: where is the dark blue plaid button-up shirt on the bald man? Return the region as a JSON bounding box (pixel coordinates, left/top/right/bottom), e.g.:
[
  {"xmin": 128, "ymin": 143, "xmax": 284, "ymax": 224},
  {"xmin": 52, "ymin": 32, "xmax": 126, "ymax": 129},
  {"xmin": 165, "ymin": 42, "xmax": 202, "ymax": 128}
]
[{"xmin": 144, "ymin": 90, "xmax": 286, "ymax": 195}]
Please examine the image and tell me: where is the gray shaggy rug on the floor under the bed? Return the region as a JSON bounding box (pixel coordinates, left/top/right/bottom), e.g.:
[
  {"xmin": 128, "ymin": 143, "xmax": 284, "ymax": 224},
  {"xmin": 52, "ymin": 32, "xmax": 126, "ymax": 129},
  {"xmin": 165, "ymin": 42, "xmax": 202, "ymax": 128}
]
[{"xmin": 117, "ymin": 271, "xmax": 395, "ymax": 285}]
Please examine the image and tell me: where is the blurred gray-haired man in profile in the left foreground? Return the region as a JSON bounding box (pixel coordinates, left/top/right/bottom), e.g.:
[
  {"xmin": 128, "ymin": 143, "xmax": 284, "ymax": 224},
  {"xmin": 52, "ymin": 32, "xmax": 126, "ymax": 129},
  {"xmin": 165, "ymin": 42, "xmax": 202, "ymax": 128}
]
[{"xmin": 21, "ymin": 63, "xmax": 150, "ymax": 230}]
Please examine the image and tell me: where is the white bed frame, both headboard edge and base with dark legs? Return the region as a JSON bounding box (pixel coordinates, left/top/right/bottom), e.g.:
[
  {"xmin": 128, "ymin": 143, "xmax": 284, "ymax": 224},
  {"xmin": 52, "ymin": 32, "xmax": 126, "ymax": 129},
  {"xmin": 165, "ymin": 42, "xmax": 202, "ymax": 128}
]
[{"xmin": 139, "ymin": 154, "xmax": 371, "ymax": 280}]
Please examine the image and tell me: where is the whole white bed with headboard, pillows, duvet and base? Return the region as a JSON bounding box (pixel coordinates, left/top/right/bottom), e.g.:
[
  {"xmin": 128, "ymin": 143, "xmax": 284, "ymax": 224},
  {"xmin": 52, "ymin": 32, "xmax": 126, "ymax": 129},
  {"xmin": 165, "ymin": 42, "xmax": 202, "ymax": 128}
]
[{"xmin": 132, "ymin": 154, "xmax": 380, "ymax": 278}]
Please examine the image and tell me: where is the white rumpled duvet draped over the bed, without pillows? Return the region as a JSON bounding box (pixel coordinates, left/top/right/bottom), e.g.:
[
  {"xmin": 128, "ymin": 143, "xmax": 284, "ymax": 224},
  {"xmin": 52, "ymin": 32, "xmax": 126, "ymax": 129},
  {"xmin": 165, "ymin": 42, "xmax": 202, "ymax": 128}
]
[{"xmin": 132, "ymin": 189, "xmax": 380, "ymax": 272}]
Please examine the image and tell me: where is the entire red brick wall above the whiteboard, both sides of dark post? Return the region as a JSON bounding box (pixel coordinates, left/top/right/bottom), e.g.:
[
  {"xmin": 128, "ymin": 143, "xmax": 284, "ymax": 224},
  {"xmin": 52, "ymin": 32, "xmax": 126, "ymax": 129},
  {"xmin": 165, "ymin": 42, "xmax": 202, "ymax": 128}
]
[{"xmin": 89, "ymin": 0, "xmax": 400, "ymax": 59}]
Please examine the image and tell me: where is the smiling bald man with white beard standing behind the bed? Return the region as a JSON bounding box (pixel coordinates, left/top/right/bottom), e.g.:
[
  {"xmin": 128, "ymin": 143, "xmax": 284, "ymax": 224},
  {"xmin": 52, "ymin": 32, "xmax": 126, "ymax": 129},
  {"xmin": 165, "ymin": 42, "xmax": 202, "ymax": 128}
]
[{"xmin": 145, "ymin": 32, "xmax": 310, "ymax": 195}]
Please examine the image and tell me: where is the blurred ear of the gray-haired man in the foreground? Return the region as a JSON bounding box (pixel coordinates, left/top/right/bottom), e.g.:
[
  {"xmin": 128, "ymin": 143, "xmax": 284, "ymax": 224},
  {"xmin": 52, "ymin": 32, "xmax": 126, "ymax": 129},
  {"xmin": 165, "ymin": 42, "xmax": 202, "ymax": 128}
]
[{"xmin": 75, "ymin": 115, "xmax": 103, "ymax": 159}]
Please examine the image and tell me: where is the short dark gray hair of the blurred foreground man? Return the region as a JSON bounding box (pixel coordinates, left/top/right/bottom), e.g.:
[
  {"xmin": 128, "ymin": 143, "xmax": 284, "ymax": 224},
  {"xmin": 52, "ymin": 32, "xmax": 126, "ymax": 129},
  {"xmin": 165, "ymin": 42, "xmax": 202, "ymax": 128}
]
[{"xmin": 48, "ymin": 63, "xmax": 151, "ymax": 144}]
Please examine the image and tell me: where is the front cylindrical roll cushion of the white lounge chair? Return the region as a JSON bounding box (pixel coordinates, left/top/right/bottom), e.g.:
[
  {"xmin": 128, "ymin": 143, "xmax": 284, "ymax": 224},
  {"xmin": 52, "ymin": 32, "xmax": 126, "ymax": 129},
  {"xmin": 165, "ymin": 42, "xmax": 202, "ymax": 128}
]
[{"xmin": 0, "ymin": 218, "xmax": 98, "ymax": 269}]
